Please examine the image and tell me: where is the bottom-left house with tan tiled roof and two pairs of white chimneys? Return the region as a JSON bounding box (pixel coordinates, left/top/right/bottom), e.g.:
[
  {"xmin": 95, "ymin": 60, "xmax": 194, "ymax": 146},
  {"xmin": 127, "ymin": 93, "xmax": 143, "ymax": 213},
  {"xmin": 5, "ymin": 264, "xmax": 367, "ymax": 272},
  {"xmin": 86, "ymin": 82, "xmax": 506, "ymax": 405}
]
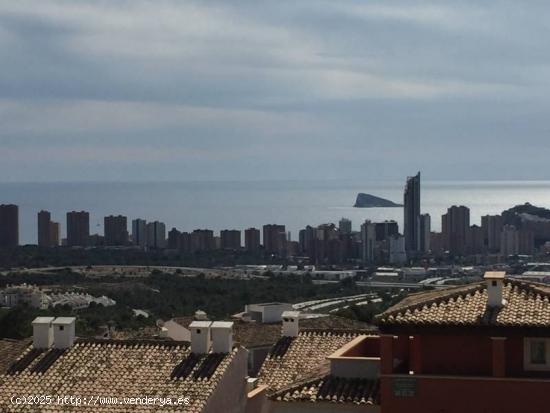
[{"xmin": 0, "ymin": 317, "xmax": 247, "ymax": 413}]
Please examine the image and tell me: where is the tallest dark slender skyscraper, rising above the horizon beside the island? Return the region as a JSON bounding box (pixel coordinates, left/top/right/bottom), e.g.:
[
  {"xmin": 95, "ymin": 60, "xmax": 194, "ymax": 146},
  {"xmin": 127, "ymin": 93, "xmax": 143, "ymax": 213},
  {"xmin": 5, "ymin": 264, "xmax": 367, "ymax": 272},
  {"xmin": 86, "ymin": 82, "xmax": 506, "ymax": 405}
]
[{"xmin": 403, "ymin": 172, "xmax": 420, "ymax": 253}]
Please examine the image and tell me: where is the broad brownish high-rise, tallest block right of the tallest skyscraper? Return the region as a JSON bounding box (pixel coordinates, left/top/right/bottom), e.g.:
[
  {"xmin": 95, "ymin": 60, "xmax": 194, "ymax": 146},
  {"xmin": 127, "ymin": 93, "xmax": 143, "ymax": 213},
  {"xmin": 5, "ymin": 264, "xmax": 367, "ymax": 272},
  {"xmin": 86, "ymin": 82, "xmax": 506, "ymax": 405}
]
[{"xmin": 441, "ymin": 205, "xmax": 470, "ymax": 255}]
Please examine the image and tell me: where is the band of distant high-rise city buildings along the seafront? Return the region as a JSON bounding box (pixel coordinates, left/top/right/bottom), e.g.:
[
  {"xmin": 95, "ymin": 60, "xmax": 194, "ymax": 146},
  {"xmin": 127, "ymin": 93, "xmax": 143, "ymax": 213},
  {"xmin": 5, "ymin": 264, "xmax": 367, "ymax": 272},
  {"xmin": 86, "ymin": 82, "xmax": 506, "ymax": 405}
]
[{"xmin": 0, "ymin": 171, "xmax": 550, "ymax": 265}]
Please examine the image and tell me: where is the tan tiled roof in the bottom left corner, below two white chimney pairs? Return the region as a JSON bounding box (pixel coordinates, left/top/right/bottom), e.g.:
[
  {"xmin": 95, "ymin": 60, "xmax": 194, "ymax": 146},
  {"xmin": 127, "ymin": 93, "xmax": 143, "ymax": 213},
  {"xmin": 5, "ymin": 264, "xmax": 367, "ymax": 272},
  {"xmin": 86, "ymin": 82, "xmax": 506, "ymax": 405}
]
[{"xmin": 0, "ymin": 340, "xmax": 238, "ymax": 413}]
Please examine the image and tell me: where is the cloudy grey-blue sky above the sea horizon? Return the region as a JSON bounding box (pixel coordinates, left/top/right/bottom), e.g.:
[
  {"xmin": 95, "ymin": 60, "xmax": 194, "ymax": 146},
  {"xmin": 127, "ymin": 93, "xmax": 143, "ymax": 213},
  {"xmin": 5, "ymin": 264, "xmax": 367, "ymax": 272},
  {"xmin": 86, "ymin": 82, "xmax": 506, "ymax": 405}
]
[{"xmin": 0, "ymin": 0, "xmax": 550, "ymax": 182}]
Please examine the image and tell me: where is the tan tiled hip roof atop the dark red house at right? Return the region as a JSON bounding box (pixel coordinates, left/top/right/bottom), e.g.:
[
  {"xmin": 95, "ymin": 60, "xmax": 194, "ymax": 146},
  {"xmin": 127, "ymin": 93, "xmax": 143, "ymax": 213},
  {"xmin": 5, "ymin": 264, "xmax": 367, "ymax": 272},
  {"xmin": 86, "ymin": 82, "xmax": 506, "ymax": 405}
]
[{"xmin": 376, "ymin": 275, "xmax": 550, "ymax": 330}]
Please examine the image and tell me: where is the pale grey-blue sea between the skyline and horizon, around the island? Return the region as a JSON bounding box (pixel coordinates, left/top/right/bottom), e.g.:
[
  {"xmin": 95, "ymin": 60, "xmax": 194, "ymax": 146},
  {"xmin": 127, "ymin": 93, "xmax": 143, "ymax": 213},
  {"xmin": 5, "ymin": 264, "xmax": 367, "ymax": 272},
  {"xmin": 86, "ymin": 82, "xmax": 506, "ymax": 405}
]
[{"xmin": 0, "ymin": 180, "xmax": 550, "ymax": 244}]
